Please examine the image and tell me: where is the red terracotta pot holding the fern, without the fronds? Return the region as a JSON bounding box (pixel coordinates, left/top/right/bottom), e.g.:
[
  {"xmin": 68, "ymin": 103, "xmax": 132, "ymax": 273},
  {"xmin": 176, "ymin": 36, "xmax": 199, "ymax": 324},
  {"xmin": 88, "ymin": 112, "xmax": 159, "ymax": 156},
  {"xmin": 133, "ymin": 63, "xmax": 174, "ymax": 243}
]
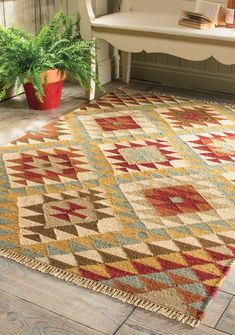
[{"xmin": 24, "ymin": 70, "xmax": 66, "ymax": 110}]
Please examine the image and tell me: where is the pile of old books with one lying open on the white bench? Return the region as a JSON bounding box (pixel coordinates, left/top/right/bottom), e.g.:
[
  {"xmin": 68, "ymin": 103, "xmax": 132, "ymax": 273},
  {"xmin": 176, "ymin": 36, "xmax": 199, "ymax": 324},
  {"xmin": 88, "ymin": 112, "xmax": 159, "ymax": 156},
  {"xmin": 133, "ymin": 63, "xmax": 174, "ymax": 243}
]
[{"xmin": 179, "ymin": 0, "xmax": 226, "ymax": 29}]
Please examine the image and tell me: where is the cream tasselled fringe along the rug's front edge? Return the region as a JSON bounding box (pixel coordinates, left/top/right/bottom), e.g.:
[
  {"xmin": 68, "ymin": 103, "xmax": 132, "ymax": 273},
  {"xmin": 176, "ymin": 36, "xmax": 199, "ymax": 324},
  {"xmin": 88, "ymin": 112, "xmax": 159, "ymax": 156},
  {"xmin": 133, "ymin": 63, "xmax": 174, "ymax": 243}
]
[{"xmin": 0, "ymin": 249, "xmax": 200, "ymax": 328}]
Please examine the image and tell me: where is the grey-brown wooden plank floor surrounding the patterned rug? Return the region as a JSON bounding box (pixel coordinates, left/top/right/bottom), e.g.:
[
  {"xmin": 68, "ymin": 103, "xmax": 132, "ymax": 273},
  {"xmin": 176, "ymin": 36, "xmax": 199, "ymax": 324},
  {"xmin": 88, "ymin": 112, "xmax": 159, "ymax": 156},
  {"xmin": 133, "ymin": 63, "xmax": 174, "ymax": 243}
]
[{"xmin": 0, "ymin": 82, "xmax": 235, "ymax": 335}]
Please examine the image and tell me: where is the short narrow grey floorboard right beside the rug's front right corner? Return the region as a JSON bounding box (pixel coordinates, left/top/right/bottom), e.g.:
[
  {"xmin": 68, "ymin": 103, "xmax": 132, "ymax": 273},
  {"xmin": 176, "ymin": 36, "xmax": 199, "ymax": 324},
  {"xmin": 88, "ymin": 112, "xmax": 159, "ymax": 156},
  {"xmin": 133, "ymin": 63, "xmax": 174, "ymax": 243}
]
[{"xmin": 202, "ymin": 291, "xmax": 233, "ymax": 328}]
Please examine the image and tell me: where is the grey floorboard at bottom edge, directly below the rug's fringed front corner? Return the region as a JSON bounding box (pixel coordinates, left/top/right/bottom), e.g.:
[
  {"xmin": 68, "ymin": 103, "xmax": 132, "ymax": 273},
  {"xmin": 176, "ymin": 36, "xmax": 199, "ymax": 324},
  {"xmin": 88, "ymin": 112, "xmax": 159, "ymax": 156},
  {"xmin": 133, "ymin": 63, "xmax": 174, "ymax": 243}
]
[{"xmin": 115, "ymin": 309, "xmax": 229, "ymax": 335}]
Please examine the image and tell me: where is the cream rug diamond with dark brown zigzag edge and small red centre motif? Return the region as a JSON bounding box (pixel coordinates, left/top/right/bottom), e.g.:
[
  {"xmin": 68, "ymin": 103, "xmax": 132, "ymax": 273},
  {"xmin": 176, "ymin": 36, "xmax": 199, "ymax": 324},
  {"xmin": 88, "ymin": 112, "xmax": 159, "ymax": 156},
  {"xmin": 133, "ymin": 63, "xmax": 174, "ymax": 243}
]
[{"xmin": 18, "ymin": 188, "xmax": 120, "ymax": 245}]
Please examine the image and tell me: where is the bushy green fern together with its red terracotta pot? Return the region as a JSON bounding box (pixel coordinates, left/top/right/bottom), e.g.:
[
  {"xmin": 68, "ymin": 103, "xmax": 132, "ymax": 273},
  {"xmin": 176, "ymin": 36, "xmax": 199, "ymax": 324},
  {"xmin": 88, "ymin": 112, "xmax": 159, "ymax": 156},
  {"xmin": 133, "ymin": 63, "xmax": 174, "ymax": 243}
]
[{"xmin": 0, "ymin": 12, "xmax": 97, "ymax": 110}]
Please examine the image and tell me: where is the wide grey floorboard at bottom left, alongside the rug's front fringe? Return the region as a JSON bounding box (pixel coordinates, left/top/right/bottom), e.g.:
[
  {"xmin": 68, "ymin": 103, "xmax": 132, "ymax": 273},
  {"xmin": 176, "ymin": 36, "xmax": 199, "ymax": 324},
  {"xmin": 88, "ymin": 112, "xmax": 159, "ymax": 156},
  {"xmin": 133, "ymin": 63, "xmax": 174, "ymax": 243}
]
[{"xmin": 0, "ymin": 258, "xmax": 134, "ymax": 335}]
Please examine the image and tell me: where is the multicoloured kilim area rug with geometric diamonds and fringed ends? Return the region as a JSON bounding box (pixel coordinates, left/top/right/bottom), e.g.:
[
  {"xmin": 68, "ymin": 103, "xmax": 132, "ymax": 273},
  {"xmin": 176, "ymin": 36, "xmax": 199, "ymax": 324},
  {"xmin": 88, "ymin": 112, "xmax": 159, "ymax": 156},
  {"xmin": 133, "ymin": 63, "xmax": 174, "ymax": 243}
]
[{"xmin": 0, "ymin": 90, "xmax": 235, "ymax": 327}]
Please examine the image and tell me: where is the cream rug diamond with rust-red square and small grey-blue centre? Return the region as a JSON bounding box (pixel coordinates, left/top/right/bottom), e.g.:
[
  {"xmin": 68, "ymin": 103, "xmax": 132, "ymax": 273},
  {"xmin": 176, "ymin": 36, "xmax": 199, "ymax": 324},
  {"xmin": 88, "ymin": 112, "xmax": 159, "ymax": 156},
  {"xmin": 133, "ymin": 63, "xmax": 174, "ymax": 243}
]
[{"xmin": 121, "ymin": 175, "xmax": 235, "ymax": 229}]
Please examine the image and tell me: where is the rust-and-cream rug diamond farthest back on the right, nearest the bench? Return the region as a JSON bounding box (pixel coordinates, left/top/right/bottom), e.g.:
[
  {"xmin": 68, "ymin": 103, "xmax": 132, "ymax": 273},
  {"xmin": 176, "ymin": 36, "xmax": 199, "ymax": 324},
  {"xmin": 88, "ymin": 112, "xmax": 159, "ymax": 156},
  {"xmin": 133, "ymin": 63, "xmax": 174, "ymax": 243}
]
[{"xmin": 156, "ymin": 105, "xmax": 233, "ymax": 129}]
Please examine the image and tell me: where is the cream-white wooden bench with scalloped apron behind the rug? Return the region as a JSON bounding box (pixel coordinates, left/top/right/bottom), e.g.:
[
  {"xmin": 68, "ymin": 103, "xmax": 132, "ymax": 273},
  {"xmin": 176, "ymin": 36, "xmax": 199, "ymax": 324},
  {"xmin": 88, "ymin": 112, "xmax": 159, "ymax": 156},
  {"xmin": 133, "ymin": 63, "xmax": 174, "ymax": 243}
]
[{"xmin": 79, "ymin": 0, "xmax": 235, "ymax": 99}]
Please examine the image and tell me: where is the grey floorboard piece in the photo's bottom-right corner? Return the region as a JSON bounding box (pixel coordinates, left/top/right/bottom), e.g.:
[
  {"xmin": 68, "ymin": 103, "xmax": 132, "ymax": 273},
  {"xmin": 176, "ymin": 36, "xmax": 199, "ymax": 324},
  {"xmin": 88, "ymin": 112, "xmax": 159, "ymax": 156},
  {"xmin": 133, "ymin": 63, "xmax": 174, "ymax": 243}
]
[{"xmin": 216, "ymin": 297, "xmax": 235, "ymax": 335}]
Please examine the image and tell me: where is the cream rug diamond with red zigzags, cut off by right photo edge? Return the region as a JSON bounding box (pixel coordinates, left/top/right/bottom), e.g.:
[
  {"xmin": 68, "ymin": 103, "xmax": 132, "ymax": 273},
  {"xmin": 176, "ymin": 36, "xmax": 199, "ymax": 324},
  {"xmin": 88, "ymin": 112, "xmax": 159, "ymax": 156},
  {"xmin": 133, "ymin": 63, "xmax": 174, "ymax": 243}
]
[{"xmin": 182, "ymin": 131, "xmax": 235, "ymax": 165}]
